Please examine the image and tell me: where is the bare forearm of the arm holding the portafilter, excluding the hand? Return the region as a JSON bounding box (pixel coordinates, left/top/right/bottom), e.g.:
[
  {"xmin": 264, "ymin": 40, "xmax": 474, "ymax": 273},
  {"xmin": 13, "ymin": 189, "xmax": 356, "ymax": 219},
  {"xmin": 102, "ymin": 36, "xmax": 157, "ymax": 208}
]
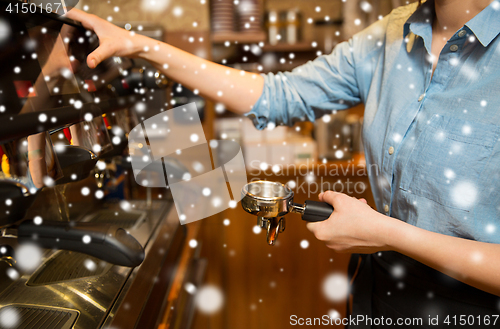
[{"xmin": 385, "ymin": 215, "xmax": 500, "ymax": 296}]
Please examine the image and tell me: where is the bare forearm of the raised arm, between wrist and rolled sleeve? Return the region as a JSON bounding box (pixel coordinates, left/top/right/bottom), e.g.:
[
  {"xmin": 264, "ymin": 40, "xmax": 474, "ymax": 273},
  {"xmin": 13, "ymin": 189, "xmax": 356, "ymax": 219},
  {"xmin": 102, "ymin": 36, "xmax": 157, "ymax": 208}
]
[{"xmin": 133, "ymin": 37, "xmax": 264, "ymax": 113}]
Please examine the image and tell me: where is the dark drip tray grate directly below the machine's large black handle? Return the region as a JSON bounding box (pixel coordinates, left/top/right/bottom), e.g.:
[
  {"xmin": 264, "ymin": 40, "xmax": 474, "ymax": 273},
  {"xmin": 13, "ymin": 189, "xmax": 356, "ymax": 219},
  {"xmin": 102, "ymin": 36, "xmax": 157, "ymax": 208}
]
[{"xmin": 26, "ymin": 251, "xmax": 112, "ymax": 286}]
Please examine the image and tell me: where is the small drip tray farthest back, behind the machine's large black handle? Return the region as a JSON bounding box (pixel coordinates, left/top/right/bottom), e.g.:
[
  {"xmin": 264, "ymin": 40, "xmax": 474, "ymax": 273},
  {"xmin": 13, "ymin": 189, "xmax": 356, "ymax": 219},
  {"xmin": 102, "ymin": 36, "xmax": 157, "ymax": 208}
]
[{"xmin": 84, "ymin": 209, "xmax": 146, "ymax": 229}]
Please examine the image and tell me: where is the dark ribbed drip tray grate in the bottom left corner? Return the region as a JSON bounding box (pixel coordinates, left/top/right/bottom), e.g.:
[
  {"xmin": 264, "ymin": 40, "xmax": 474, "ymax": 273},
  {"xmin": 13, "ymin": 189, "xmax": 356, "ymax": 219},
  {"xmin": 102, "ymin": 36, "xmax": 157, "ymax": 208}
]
[{"xmin": 0, "ymin": 304, "xmax": 79, "ymax": 329}]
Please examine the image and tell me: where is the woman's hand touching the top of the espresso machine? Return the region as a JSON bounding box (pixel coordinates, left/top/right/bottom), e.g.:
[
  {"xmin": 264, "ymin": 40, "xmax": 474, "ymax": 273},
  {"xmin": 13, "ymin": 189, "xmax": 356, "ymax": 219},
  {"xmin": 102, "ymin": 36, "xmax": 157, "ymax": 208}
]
[{"xmin": 65, "ymin": 8, "xmax": 147, "ymax": 69}]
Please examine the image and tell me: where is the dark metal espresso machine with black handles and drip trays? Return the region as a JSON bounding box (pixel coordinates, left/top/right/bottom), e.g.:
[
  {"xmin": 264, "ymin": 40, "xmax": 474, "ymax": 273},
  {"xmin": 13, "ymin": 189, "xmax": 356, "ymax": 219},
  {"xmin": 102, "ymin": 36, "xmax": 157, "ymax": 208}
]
[{"xmin": 0, "ymin": 0, "xmax": 204, "ymax": 329}]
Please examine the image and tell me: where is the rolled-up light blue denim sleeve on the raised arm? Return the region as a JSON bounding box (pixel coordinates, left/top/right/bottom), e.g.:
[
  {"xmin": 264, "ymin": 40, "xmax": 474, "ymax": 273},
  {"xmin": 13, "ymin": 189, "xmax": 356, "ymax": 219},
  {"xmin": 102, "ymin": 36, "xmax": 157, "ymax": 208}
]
[{"xmin": 246, "ymin": 19, "xmax": 385, "ymax": 129}]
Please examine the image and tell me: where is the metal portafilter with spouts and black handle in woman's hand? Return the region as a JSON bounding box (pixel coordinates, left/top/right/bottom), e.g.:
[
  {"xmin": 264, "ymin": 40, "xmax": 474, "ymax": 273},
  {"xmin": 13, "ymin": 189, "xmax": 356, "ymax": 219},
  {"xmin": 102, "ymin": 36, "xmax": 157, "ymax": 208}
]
[{"xmin": 241, "ymin": 181, "xmax": 333, "ymax": 246}]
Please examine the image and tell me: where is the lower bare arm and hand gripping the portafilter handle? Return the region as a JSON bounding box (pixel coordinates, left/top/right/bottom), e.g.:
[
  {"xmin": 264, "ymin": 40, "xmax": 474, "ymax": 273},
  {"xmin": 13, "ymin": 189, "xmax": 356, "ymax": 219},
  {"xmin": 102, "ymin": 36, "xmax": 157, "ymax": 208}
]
[{"xmin": 307, "ymin": 191, "xmax": 500, "ymax": 296}]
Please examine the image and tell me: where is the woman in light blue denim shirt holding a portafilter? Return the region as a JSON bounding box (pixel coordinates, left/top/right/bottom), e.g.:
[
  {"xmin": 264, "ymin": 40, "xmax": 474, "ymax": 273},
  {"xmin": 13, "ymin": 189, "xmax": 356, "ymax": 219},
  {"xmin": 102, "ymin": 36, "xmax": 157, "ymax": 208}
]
[{"xmin": 67, "ymin": 0, "xmax": 500, "ymax": 328}]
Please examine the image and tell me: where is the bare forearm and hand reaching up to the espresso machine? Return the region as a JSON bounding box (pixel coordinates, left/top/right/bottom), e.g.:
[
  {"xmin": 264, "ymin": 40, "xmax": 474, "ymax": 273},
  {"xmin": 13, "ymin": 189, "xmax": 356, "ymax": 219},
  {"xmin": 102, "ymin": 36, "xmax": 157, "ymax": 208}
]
[{"xmin": 66, "ymin": 9, "xmax": 264, "ymax": 113}]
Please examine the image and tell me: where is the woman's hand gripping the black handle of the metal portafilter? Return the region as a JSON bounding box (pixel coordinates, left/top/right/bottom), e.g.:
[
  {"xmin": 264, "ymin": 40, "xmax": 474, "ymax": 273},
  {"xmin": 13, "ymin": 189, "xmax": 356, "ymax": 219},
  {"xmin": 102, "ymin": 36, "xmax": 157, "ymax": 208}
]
[{"xmin": 307, "ymin": 191, "xmax": 396, "ymax": 253}]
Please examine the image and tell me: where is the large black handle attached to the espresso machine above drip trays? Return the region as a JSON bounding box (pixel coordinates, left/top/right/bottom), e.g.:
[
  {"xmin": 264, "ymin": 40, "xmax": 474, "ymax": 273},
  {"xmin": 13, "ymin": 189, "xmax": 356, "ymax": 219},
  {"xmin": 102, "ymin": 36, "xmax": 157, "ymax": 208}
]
[{"xmin": 17, "ymin": 220, "xmax": 145, "ymax": 267}]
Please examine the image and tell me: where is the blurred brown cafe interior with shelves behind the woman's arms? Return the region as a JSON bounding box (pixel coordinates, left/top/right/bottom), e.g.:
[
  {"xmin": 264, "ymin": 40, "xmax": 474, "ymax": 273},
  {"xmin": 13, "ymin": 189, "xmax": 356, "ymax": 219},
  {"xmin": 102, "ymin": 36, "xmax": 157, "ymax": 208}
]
[{"xmin": 0, "ymin": 0, "xmax": 418, "ymax": 329}]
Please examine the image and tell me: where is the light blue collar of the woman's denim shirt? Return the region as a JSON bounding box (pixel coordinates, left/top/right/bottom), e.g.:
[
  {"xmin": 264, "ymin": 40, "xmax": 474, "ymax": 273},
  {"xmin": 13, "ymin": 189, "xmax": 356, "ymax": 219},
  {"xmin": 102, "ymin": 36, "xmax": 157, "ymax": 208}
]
[{"xmin": 404, "ymin": 0, "xmax": 500, "ymax": 48}]
